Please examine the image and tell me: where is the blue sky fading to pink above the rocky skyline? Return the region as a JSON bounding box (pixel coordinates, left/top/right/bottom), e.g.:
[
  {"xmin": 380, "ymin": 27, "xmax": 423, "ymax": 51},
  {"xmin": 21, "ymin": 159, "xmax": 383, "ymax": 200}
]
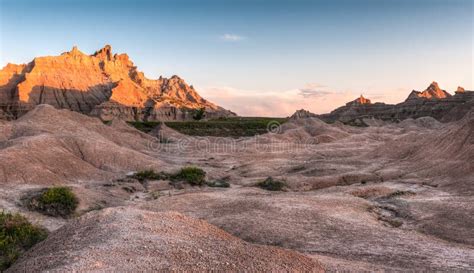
[{"xmin": 0, "ymin": 0, "xmax": 474, "ymax": 116}]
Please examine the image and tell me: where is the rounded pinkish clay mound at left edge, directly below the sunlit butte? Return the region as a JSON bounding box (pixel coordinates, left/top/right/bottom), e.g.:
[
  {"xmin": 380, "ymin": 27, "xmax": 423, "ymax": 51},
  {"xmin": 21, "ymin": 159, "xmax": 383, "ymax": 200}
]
[{"xmin": 0, "ymin": 105, "xmax": 161, "ymax": 185}]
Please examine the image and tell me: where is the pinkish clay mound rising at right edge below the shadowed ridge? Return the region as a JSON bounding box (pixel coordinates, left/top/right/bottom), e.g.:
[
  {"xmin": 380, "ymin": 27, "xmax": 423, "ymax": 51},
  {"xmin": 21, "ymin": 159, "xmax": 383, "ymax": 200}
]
[{"xmin": 374, "ymin": 111, "xmax": 474, "ymax": 194}]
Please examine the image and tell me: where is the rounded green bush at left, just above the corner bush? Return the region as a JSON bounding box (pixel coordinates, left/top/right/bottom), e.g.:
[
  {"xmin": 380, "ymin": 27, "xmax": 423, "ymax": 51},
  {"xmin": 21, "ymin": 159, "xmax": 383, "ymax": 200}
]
[{"xmin": 27, "ymin": 187, "xmax": 79, "ymax": 217}]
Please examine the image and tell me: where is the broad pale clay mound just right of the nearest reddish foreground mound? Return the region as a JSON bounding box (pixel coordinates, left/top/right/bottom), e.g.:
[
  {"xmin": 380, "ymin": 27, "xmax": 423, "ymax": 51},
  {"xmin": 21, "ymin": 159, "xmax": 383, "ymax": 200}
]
[{"xmin": 143, "ymin": 186, "xmax": 474, "ymax": 272}]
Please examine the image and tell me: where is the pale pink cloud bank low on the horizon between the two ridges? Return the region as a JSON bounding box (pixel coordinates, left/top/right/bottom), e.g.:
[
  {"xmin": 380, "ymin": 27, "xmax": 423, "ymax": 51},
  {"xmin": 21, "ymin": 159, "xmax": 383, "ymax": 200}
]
[{"xmin": 198, "ymin": 86, "xmax": 355, "ymax": 117}]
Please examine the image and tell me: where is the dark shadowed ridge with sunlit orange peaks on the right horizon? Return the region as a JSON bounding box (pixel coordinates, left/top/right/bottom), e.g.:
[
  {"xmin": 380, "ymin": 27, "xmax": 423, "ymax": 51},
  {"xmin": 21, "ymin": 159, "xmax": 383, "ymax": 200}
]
[{"xmin": 319, "ymin": 82, "xmax": 474, "ymax": 124}]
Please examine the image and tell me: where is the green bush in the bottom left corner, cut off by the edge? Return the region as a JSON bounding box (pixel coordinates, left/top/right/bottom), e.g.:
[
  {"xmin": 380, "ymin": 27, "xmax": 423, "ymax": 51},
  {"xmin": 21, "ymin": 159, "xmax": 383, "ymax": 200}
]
[{"xmin": 0, "ymin": 211, "xmax": 48, "ymax": 272}]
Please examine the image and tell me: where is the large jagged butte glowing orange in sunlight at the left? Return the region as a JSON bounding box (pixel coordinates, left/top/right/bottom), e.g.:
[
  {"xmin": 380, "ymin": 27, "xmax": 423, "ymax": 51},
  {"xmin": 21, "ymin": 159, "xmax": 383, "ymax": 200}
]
[{"xmin": 0, "ymin": 45, "xmax": 235, "ymax": 120}]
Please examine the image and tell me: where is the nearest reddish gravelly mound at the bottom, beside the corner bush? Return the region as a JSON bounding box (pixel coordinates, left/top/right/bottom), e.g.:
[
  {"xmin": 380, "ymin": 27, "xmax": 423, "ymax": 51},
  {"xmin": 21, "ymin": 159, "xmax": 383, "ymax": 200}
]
[{"xmin": 9, "ymin": 207, "xmax": 323, "ymax": 272}]
